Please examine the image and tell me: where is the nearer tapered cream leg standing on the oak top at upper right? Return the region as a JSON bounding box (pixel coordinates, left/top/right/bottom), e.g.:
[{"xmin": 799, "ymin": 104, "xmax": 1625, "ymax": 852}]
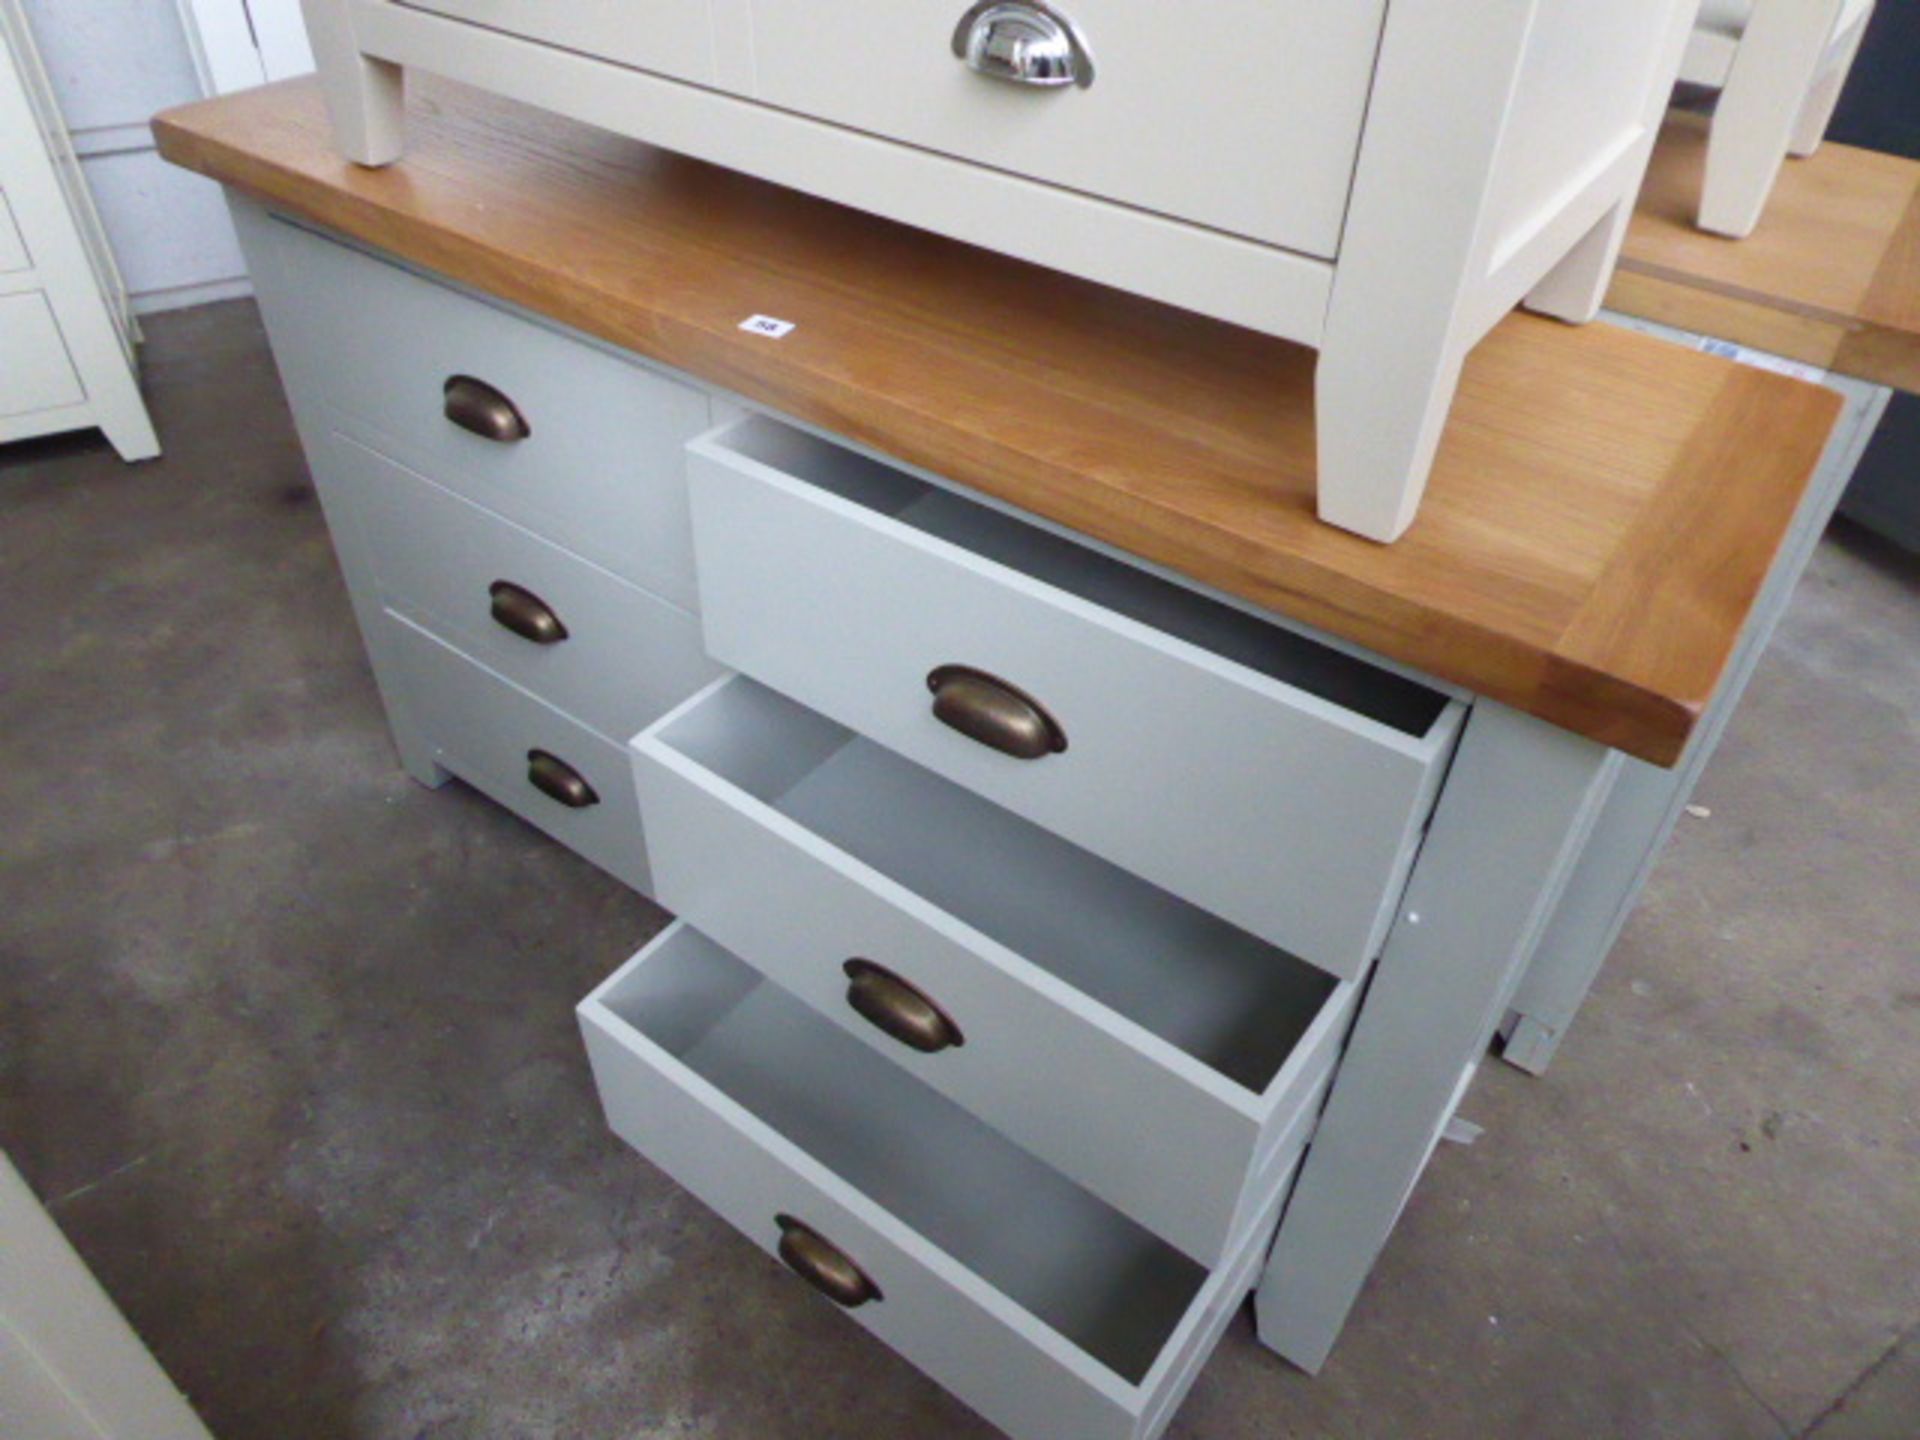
[{"xmin": 1699, "ymin": 0, "xmax": 1841, "ymax": 240}]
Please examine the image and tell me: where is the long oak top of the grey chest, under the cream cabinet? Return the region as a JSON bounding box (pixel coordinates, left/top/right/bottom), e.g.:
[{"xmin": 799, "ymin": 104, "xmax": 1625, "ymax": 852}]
[{"xmin": 154, "ymin": 81, "xmax": 1839, "ymax": 764}]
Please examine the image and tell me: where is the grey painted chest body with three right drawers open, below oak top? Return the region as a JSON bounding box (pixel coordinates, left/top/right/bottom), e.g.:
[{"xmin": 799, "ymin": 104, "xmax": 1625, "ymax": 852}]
[{"xmin": 236, "ymin": 200, "xmax": 1873, "ymax": 1440}]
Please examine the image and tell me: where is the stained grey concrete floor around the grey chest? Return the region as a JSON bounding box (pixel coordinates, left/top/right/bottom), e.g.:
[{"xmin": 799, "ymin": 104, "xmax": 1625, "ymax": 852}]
[{"xmin": 0, "ymin": 303, "xmax": 1920, "ymax": 1440}]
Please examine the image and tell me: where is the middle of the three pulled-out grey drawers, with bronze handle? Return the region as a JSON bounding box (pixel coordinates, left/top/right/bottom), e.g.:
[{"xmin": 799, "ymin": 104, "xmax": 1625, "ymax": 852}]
[{"xmin": 634, "ymin": 676, "xmax": 1356, "ymax": 1263}]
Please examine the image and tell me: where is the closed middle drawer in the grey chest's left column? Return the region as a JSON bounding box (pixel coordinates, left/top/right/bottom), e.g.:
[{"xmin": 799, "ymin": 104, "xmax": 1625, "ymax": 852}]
[{"xmin": 326, "ymin": 434, "xmax": 720, "ymax": 745}]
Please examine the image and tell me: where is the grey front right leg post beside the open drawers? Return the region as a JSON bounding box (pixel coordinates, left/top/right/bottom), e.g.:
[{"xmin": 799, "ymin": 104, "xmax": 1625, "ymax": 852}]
[{"xmin": 1254, "ymin": 701, "xmax": 1620, "ymax": 1371}]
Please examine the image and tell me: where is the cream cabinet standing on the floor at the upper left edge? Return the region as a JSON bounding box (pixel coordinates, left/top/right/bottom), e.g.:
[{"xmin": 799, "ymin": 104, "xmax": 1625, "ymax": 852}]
[{"xmin": 0, "ymin": 0, "xmax": 159, "ymax": 461}]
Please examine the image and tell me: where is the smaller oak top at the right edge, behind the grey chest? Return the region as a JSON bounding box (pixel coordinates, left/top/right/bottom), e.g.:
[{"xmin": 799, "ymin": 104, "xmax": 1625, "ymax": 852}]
[{"xmin": 1607, "ymin": 115, "xmax": 1920, "ymax": 394}]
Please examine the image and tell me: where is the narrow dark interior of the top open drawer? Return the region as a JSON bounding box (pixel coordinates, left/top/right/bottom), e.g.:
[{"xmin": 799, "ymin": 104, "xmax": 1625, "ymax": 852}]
[{"xmin": 710, "ymin": 415, "xmax": 1448, "ymax": 737}]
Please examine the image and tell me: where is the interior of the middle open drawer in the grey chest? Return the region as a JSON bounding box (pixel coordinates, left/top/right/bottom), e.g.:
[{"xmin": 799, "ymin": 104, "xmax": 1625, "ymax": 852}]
[{"xmin": 653, "ymin": 676, "xmax": 1338, "ymax": 1092}]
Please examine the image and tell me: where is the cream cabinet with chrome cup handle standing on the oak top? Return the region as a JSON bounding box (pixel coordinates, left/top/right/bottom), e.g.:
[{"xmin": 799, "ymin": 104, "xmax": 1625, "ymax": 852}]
[{"xmin": 303, "ymin": 0, "xmax": 1695, "ymax": 541}]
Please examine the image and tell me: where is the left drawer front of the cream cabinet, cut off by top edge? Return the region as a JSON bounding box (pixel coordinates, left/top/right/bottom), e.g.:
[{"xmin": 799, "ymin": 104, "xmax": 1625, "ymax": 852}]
[{"xmin": 403, "ymin": 0, "xmax": 721, "ymax": 83}]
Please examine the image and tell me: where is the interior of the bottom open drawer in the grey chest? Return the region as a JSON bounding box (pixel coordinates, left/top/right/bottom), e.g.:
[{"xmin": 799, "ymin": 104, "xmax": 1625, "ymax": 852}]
[{"xmin": 595, "ymin": 927, "xmax": 1208, "ymax": 1384}]
